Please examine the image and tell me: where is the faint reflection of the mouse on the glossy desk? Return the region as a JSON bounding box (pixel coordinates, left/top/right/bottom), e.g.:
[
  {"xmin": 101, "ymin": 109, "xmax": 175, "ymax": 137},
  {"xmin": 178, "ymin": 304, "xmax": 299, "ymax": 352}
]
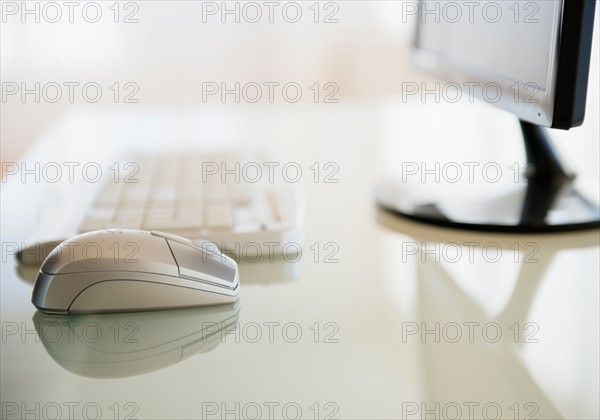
[{"xmin": 33, "ymin": 301, "xmax": 240, "ymax": 378}]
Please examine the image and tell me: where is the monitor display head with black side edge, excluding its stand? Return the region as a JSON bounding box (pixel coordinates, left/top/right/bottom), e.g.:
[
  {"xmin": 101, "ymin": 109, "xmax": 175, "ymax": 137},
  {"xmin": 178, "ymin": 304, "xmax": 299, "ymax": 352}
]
[{"xmin": 414, "ymin": 0, "xmax": 594, "ymax": 128}]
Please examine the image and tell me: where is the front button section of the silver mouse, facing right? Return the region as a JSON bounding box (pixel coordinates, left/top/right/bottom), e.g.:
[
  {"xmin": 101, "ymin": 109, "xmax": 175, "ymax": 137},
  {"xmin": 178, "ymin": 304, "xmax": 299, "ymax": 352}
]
[{"xmin": 167, "ymin": 239, "xmax": 237, "ymax": 287}]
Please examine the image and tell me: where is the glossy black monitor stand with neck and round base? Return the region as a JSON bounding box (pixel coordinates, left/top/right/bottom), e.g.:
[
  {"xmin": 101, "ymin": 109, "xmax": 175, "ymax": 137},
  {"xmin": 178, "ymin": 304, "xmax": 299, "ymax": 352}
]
[{"xmin": 376, "ymin": 121, "xmax": 600, "ymax": 233}]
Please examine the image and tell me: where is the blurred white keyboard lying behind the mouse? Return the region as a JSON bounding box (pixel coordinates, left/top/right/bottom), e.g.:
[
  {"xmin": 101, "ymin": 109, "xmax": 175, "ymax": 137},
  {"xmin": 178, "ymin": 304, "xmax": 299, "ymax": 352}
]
[{"xmin": 78, "ymin": 153, "xmax": 299, "ymax": 255}]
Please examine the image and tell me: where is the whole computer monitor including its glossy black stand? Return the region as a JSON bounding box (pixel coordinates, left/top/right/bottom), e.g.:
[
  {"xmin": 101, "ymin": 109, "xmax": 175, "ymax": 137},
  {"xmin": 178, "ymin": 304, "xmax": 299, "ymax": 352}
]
[{"xmin": 377, "ymin": 0, "xmax": 600, "ymax": 232}]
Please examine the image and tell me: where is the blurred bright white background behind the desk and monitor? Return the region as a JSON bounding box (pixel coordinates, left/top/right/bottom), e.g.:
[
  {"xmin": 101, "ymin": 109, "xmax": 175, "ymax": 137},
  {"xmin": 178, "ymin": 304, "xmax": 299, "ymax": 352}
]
[{"xmin": 0, "ymin": 1, "xmax": 599, "ymax": 167}]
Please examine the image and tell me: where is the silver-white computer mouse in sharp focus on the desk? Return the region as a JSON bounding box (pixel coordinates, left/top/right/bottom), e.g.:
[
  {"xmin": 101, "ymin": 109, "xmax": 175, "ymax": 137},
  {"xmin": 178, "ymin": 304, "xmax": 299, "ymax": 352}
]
[{"xmin": 32, "ymin": 229, "xmax": 239, "ymax": 314}]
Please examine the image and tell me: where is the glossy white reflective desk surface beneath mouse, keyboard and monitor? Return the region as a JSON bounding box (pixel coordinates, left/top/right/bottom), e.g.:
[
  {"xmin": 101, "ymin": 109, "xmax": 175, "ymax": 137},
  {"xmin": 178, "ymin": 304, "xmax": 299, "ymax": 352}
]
[{"xmin": 1, "ymin": 103, "xmax": 600, "ymax": 419}]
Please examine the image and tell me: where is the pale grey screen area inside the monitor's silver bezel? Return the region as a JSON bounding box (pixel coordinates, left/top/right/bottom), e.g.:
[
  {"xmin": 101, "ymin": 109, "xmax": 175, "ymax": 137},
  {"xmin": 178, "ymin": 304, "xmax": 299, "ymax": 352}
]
[{"xmin": 419, "ymin": 1, "xmax": 560, "ymax": 91}]
